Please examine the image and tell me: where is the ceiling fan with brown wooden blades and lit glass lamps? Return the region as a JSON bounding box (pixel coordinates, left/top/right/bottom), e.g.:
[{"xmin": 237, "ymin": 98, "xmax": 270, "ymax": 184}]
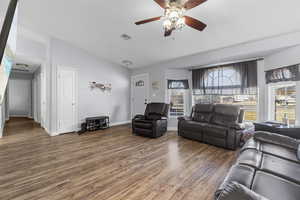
[{"xmin": 135, "ymin": 0, "xmax": 207, "ymax": 37}]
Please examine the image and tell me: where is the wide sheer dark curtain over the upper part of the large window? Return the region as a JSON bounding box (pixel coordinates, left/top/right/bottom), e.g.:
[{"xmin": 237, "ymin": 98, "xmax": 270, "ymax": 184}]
[{"xmin": 192, "ymin": 61, "xmax": 257, "ymax": 95}]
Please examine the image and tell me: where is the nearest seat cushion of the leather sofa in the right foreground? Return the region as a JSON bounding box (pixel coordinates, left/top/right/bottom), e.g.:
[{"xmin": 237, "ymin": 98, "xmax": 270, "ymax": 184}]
[{"xmin": 252, "ymin": 171, "xmax": 300, "ymax": 200}]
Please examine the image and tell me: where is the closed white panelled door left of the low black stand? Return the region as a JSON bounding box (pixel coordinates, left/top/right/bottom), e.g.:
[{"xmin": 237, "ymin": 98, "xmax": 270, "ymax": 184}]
[{"xmin": 57, "ymin": 68, "xmax": 77, "ymax": 134}]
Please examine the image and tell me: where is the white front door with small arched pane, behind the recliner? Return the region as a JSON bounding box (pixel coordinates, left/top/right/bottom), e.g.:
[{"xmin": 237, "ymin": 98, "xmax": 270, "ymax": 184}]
[{"xmin": 131, "ymin": 74, "xmax": 149, "ymax": 117}]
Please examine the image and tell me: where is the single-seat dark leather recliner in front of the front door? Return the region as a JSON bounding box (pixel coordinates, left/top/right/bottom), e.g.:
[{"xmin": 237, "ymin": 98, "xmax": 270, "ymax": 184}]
[{"xmin": 132, "ymin": 103, "xmax": 169, "ymax": 138}]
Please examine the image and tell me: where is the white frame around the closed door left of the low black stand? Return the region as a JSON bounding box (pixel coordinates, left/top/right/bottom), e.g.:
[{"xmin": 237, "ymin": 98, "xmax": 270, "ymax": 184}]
[{"xmin": 56, "ymin": 66, "xmax": 79, "ymax": 135}]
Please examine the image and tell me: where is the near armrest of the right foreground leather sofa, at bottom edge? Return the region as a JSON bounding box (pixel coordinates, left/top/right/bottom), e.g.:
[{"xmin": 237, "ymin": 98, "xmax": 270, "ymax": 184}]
[{"xmin": 217, "ymin": 182, "xmax": 268, "ymax": 200}]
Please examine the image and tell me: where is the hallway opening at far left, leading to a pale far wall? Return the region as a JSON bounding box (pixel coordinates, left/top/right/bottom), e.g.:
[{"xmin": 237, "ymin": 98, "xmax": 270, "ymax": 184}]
[{"xmin": 7, "ymin": 62, "xmax": 42, "ymax": 124}]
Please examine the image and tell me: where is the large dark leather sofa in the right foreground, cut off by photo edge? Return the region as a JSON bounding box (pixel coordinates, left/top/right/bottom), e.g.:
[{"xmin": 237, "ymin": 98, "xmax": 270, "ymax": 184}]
[{"xmin": 216, "ymin": 132, "xmax": 300, "ymax": 200}]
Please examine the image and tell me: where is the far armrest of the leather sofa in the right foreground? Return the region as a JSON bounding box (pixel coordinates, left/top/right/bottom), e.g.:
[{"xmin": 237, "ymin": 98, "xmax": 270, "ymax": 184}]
[{"xmin": 254, "ymin": 131, "xmax": 300, "ymax": 151}]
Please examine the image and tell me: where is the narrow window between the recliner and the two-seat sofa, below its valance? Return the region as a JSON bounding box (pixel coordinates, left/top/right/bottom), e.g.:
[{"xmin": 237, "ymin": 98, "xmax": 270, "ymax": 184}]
[{"xmin": 169, "ymin": 89, "xmax": 186, "ymax": 117}]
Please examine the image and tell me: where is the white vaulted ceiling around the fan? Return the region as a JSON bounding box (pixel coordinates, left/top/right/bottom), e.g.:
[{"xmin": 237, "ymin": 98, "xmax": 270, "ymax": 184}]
[{"xmin": 19, "ymin": 0, "xmax": 300, "ymax": 68}]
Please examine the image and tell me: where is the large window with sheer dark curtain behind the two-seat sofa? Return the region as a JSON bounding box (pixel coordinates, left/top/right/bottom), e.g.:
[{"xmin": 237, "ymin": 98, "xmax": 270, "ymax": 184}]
[{"xmin": 193, "ymin": 62, "xmax": 257, "ymax": 121}]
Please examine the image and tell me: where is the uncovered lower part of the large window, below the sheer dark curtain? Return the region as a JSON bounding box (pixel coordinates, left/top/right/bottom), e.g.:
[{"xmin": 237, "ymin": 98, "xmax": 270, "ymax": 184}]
[{"xmin": 194, "ymin": 95, "xmax": 257, "ymax": 121}]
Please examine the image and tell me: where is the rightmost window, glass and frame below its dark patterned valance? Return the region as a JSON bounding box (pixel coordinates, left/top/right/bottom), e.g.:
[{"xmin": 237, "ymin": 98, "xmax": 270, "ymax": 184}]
[{"xmin": 270, "ymin": 83, "xmax": 296, "ymax": 125}]
